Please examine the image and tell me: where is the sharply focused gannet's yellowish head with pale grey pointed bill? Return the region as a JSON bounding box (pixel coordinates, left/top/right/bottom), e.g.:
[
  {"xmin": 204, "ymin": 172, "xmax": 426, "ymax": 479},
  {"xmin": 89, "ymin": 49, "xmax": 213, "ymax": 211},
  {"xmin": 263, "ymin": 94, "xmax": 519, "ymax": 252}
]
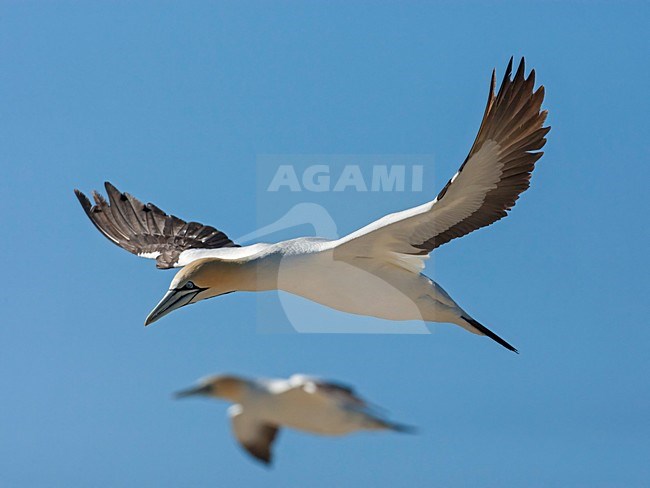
[{"xmin": 144, "ymin": 258, "xmax": 241, "ymax": 325}]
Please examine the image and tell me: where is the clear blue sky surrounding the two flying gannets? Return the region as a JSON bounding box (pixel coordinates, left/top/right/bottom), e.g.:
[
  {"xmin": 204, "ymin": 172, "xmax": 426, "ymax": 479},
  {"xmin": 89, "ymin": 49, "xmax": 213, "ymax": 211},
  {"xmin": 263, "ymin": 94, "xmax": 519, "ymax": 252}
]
[{"xmin": 0, "ymin": 1, "xmax": 650, "ymax": 487}]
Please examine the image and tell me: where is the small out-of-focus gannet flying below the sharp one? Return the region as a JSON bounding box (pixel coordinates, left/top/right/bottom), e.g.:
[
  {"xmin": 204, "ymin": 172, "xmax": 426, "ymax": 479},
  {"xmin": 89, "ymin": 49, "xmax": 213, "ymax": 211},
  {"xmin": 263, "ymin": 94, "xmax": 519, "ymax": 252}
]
[{"xmin": 176, "ymin": 375, "xmax": 414, "ymax": 464}]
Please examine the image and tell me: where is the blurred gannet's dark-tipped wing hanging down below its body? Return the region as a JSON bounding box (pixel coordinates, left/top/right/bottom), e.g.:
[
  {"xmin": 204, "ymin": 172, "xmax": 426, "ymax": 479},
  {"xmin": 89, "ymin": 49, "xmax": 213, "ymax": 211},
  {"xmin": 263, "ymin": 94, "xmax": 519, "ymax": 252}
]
[{"xmin": 228, "ymin": 405, "xmax": 279, "ymax": 464}]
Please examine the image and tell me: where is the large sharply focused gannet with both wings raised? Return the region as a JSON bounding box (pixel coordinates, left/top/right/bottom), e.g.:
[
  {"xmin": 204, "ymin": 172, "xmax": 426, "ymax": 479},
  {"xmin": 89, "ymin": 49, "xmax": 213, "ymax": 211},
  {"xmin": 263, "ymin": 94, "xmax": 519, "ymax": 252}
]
[{"xmin": 75, "ymin": 58, "xmax": 550, "ymax": 352}]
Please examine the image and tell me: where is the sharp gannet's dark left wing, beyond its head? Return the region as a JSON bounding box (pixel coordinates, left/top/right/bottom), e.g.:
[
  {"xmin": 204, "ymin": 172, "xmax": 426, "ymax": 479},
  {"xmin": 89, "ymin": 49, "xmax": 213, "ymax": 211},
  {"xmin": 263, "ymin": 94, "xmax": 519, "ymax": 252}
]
[{"xmin": 74, "ymin": 182, "xmax": 239, "ymax": 269}]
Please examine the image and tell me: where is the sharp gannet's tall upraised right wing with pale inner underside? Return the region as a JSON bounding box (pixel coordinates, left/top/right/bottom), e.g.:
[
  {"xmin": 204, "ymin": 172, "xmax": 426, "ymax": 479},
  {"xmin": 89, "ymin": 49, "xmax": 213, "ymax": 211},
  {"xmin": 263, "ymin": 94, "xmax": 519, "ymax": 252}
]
[{"xmin": 336, "ymin": 58, "xmax": 550, "ymax": 267}]
